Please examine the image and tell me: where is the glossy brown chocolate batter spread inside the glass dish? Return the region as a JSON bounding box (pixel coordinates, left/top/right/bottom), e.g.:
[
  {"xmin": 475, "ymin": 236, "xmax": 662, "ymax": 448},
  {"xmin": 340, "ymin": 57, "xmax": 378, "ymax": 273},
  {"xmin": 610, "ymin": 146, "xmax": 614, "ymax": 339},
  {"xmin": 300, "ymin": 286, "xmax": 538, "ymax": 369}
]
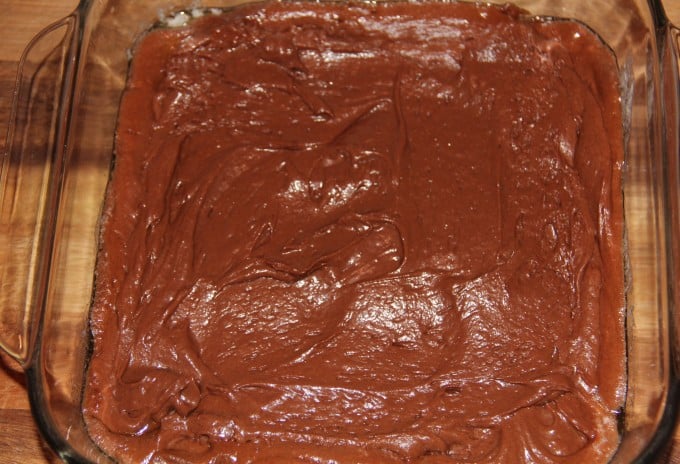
[{"xmin": 84, "ymin": 3, "xmax": 625, "ymax": 463}]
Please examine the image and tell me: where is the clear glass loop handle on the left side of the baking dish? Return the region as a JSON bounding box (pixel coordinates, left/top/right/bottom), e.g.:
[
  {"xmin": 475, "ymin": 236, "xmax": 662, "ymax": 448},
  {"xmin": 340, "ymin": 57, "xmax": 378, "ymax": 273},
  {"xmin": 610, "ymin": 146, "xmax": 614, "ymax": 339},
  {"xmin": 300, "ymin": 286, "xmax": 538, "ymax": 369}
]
[{"xmin": 0, "ymin": 15, "xmax": 77, "ymax": 366}]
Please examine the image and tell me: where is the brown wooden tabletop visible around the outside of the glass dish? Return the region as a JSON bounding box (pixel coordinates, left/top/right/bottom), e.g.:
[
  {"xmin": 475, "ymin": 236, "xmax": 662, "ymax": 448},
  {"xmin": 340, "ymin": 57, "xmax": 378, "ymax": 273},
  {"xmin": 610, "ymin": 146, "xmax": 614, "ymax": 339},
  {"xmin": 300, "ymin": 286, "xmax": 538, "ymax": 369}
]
[{"xmin": 0, "ymin": 0, "xmax": 680, "ymax": 464}]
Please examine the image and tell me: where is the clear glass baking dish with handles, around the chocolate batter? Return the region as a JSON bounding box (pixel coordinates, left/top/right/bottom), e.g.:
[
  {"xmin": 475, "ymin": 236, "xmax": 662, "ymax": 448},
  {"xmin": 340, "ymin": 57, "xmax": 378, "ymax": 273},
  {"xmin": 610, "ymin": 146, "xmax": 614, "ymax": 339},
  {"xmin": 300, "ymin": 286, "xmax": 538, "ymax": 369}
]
[{"xmin": 0, "ymin": 0, "xmax": 680, "ymax": 463}]
